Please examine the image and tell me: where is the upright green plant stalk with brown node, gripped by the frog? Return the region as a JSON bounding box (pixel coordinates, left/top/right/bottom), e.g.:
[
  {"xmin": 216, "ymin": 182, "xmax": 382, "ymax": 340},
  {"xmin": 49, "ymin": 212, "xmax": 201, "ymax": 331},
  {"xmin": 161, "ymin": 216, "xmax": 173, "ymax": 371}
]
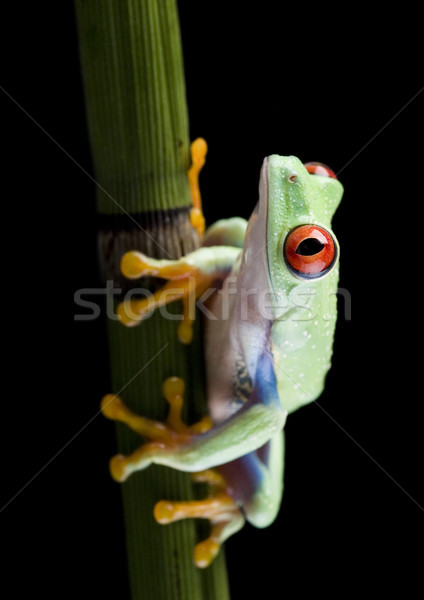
[{"xmin": 75, "ymin": 0, "xmax": 229, "ymax": 600}]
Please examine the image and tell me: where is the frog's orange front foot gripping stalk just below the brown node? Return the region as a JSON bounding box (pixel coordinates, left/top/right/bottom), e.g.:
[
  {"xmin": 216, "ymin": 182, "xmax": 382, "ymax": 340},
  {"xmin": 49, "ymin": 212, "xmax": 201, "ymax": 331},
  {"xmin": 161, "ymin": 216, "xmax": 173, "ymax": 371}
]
[{"xmin": 117, "ymin": 249, "xmax": 216, "ymax": 344}]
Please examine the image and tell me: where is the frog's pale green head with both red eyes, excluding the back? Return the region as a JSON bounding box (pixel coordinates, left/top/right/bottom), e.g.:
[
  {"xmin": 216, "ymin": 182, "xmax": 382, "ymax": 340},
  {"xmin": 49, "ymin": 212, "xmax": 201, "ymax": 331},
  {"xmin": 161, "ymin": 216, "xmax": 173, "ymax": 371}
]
[{"xmin": 260, "ymin": 155, "xmax": 343, "ymax": 300}]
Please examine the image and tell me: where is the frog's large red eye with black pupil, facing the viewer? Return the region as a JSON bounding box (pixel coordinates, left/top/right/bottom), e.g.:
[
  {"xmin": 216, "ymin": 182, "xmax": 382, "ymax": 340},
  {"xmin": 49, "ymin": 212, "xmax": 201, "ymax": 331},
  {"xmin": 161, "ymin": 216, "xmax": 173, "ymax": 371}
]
[{"xmin": 284, "ymin": 225, "xmax": 337, "ymax": 279}]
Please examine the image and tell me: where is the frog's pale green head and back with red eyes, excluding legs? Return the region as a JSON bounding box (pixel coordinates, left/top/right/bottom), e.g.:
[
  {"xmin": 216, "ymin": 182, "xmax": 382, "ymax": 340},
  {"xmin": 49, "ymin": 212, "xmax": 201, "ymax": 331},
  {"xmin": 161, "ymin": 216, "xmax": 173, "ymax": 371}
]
[{"xmin": 258, "ymin": 155, "xmax": 343, "ymax": 412}]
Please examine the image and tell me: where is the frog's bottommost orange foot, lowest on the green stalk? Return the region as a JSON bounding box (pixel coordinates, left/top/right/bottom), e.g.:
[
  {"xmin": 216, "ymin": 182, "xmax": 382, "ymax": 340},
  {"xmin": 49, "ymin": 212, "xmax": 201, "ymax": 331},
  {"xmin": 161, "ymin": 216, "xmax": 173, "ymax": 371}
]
[{"xmin": 153, "ymin": 469, "xmax": 245, "ymax": 568}]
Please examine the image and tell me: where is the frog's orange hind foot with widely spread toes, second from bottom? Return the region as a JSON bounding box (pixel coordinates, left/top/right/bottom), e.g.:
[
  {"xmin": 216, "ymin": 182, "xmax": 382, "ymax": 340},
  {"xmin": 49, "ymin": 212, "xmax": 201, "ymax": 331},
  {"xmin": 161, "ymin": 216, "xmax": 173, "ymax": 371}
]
[{"xmin": 101, "ymin": 377, "xmax": 212, "ymax": 481}]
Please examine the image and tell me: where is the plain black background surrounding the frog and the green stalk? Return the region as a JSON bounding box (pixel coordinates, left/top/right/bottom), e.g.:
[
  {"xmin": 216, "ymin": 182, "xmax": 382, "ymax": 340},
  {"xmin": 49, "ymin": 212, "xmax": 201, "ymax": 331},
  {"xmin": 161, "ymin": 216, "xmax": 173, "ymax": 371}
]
[{"xmin": 0, "ymin": 2, "xmax": 424, "ymax": 600}]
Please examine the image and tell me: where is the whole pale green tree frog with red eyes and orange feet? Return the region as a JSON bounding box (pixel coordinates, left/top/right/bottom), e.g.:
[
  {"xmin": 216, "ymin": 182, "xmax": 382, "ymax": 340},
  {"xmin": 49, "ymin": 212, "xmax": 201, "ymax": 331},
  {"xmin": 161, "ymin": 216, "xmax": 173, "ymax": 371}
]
[{"xmin": 102, "ymin": 140, "xmax": 343, "ymax": 567}]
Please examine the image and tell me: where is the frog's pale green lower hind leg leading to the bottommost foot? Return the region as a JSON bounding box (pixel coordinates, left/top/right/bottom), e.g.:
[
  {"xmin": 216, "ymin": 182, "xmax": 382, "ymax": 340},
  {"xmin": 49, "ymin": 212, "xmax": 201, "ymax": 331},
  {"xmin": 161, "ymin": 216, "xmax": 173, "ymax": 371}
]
[{"xmin": 243, "ymin": 432, "xmax": 284, "ymax": 527}]
